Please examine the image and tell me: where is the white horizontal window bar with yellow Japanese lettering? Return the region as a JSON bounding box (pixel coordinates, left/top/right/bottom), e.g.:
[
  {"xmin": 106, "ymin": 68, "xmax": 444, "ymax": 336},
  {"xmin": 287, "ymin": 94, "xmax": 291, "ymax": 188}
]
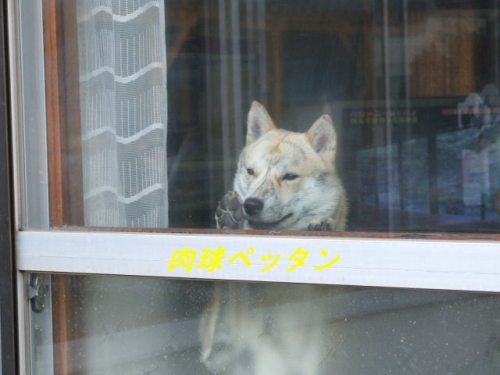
[{"xmin": 18, "ymin": 231, "xmax": 500, "ymax": 292}]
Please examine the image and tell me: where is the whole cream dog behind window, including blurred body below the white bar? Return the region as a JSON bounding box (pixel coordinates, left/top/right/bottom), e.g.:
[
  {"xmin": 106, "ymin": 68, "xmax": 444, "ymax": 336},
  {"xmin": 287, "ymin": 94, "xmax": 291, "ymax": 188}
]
[{"xmin": 200, "ymin": 102, "xmax": 348, "ymax": 375}]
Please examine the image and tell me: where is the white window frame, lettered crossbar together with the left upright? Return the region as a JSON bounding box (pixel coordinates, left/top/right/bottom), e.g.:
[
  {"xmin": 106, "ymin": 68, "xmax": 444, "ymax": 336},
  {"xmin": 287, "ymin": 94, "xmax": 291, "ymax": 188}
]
[{"xmin": 8, "ymin": 0, "xmax": 500, "ymax": 373}]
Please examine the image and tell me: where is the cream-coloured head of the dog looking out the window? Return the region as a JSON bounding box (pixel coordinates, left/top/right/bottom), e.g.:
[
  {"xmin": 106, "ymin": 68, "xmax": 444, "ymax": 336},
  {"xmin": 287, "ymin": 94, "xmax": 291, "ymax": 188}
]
[{"xmin": 234, "ymin": 102, "xmax": 342, "ymax": 230}]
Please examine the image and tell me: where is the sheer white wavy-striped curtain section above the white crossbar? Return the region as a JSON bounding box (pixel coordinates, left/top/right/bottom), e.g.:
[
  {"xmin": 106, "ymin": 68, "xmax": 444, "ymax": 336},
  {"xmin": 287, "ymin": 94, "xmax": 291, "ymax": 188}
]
[{"xmin": 78, "ymin": 0, "xmax": 168, "ymax": 228}]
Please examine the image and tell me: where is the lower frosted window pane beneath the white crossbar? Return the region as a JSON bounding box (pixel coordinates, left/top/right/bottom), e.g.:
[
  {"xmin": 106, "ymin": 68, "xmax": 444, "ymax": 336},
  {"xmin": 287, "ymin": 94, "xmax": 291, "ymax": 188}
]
[{"xmin": 31, "ymin": 276, "xmax": 500, "ymax": 375}]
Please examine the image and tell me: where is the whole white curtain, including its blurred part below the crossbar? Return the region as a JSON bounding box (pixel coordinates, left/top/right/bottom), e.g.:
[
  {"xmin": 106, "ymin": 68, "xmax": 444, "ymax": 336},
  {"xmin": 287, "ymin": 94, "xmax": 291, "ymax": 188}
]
[{"xmin": 75, "ymin": 0, "xmax": 172, "ymax": 375}]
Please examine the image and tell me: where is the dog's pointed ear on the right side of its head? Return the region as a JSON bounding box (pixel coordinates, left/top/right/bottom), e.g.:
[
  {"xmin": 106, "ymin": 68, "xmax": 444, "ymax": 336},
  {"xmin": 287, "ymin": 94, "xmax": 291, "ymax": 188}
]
[{"xmin": 306, "ymin": 115, "xmax": 337, "ymax": 162}]
